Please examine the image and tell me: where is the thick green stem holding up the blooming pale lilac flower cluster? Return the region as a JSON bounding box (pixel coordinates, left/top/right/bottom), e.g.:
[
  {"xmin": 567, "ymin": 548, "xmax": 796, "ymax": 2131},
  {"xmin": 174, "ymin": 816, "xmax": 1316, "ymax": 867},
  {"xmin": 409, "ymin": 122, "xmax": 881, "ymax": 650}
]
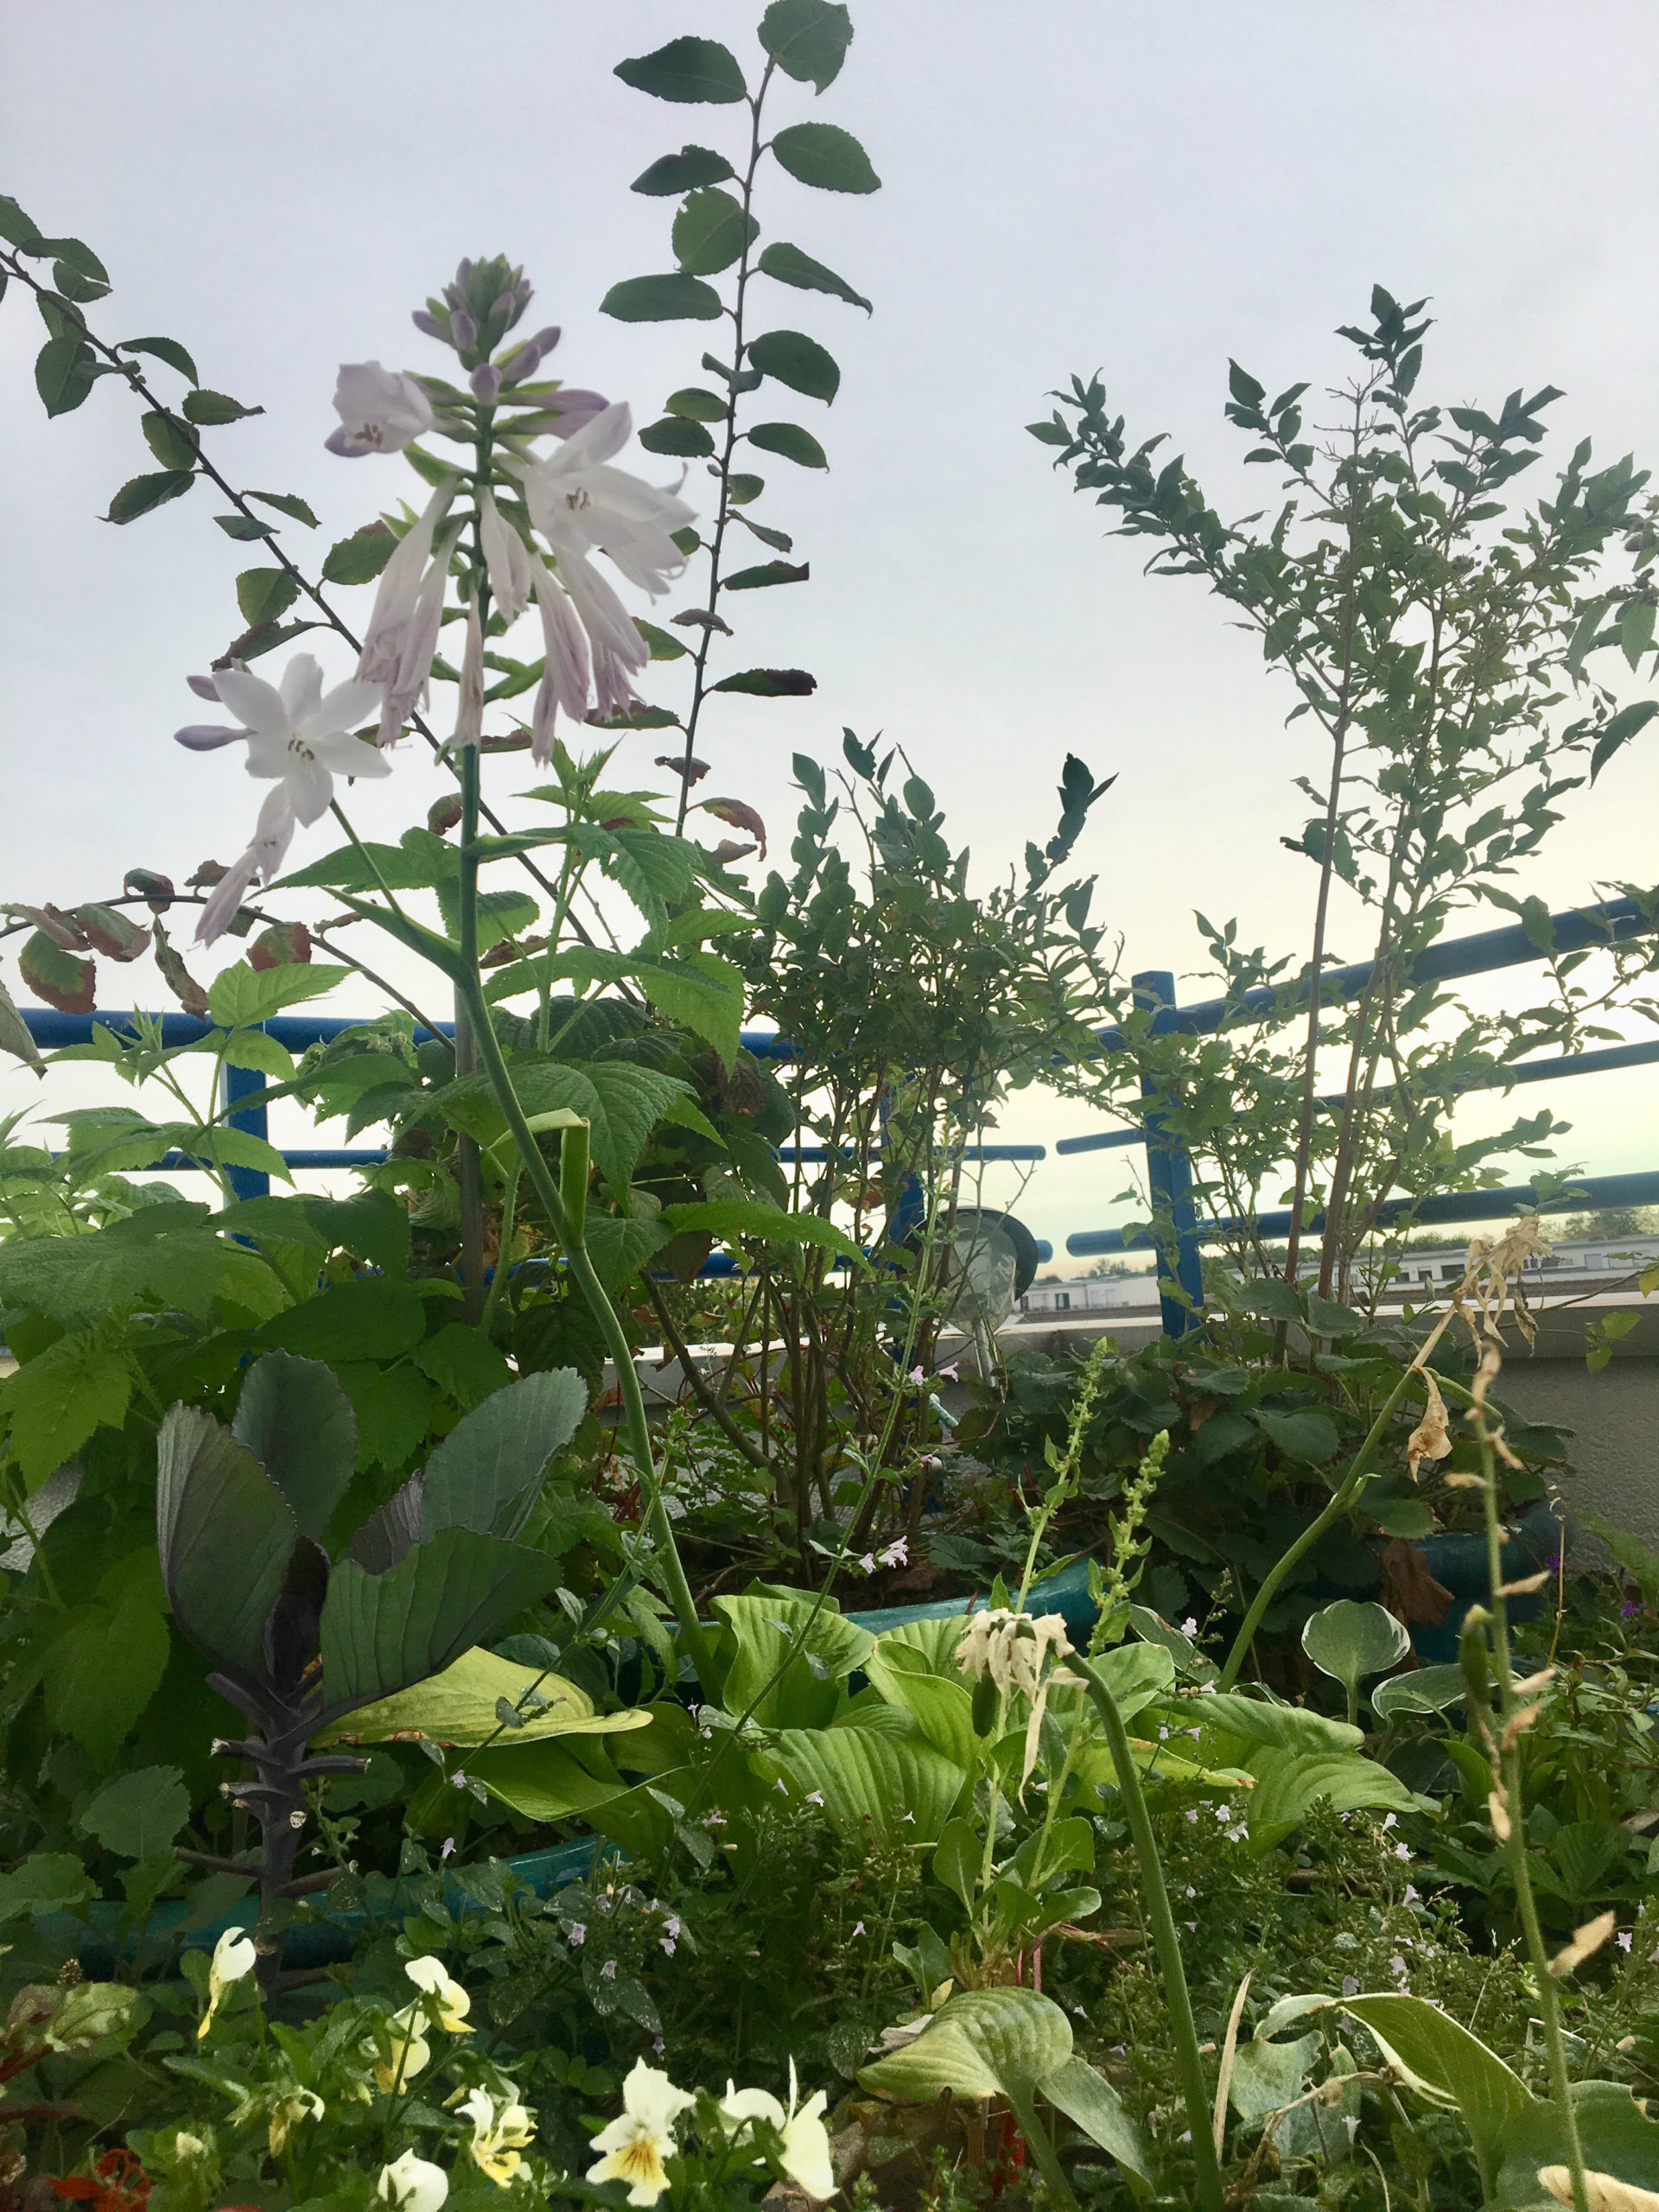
[{"xmin": 455, "ymin": 746, "xmax": 715, "ymax": 1699}]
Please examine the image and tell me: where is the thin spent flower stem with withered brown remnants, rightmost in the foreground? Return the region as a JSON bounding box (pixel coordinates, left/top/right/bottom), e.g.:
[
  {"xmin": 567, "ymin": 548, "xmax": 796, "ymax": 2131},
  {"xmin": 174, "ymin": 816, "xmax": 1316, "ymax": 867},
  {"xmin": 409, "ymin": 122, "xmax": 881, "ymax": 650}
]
[{"xmin": 1458, "ymin": 1344, "xmax": 1591, "ymax": 2212}]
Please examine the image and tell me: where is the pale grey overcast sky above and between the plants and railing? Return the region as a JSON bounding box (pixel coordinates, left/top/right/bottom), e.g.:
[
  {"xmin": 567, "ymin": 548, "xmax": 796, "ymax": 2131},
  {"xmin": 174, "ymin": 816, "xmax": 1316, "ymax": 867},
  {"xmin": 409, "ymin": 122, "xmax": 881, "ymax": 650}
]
[{"xmin": 0, "ymin": 0, "xmax": 1659, "ymax": 1241}]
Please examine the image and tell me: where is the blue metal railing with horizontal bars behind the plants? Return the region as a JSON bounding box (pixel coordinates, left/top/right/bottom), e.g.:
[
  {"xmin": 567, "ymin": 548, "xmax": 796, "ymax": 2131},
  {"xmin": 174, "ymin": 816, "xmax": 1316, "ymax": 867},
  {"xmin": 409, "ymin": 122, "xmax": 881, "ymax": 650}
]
[{"xmin": 22, "ymin": 898, "xmax": 1659, "ymax": 1336}]
